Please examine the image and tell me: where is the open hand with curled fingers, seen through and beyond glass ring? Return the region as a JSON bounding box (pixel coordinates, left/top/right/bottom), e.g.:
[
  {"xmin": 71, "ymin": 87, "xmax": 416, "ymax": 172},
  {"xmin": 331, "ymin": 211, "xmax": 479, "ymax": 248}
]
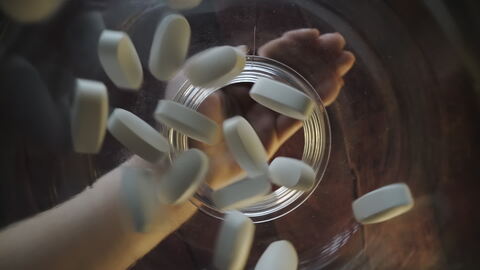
[{"xmin": 191, "ymin": 29, "xmax": 355, "ymax": 188}]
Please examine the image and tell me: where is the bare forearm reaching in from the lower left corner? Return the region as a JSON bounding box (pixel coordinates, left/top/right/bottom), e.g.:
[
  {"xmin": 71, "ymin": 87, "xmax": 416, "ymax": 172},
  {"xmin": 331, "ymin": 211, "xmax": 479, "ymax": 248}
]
[{"xmin": 0, "ymin": 155, "xmax": 196, "ymax": 269}]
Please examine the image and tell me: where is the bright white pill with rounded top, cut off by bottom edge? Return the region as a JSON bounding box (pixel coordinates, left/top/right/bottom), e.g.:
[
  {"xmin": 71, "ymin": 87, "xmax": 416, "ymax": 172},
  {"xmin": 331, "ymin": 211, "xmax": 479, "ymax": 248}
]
[{"xmin": 255, "ymin": 240, "xmax": 298, "ymax": 270}]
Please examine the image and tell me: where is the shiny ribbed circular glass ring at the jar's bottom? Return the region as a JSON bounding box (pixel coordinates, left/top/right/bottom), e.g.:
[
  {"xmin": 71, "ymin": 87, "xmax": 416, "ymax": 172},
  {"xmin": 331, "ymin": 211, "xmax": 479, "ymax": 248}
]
[{"xmin": 160, "ymin": 55, "xmax": 331, "ymax": 223}]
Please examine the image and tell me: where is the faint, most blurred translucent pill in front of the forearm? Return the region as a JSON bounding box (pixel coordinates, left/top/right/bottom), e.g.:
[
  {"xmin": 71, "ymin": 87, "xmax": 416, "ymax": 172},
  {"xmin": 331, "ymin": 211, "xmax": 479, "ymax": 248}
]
[{"xmin": 122, "ymin": 167, "xmax": 162, "ymax": 232}]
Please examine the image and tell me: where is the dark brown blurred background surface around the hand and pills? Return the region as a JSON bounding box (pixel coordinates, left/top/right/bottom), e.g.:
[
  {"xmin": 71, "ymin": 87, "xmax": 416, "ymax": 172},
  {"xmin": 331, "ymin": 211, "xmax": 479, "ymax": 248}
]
[{"xmin": 0, "ymin": 0, "xmax": 480, "ymax": 269}]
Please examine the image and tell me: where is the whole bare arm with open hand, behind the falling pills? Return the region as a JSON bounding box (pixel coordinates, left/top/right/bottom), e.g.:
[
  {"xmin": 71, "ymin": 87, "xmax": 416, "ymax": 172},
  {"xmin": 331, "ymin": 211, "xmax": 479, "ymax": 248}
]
[{"xmin": 0, "ymin": 29, "xmax": 355, "ymax": 269}]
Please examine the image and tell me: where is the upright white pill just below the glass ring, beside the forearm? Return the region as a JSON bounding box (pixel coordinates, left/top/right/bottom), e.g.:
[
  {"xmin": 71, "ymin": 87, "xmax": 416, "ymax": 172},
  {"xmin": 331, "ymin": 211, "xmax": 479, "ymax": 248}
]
[{"xmin": 213, "ymin": 211, "xmax": 255, "ymax": 270}]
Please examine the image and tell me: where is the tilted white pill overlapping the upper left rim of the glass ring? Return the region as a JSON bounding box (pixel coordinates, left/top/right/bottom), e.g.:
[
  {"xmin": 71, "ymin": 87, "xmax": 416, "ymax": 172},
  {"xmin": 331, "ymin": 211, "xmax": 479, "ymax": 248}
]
[{"xmin": 185, "ymin": 46, "xmax": 246, "ymax": 87}]
